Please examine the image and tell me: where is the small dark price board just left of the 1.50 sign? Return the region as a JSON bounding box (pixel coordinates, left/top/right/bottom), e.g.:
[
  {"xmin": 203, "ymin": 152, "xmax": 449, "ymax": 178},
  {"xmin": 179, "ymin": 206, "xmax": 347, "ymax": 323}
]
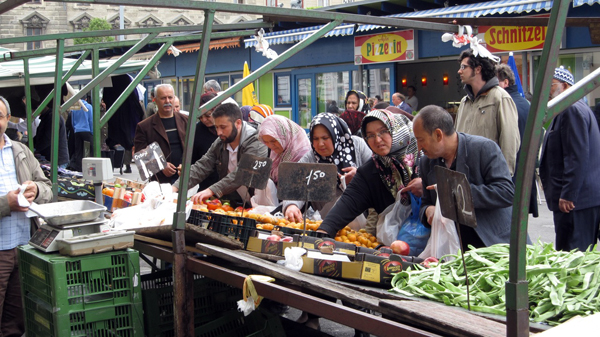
[{"xmin": 234, "ymin": 154, "xmax": 273, "ymax": 190}]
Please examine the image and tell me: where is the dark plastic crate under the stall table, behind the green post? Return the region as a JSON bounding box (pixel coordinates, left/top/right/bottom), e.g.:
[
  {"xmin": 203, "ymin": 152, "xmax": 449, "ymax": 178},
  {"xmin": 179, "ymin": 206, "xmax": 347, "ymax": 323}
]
[{"xmin": 142, "ymin": 270, "xmax": 242, "ymax": 337}]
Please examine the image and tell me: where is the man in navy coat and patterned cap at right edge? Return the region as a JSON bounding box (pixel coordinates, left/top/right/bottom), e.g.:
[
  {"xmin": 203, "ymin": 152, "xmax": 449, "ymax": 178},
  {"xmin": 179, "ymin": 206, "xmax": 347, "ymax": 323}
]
[{"xmin": 540, "ymin": 66, "xmax": 600, "ymax": 251}]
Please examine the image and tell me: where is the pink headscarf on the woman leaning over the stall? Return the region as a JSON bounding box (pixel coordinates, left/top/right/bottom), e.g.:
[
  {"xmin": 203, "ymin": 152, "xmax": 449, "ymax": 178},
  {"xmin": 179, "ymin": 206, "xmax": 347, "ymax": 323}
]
[{"xmin": 258, "ymin": 115, "xmax": 311, "ymax": 182}]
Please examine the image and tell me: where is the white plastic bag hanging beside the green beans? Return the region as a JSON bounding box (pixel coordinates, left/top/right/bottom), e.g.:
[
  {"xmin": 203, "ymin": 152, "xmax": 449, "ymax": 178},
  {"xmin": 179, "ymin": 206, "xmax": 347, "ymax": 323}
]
[{"xmin": 419, "ymin": 185, "xmax": 460, "ymax": 260}]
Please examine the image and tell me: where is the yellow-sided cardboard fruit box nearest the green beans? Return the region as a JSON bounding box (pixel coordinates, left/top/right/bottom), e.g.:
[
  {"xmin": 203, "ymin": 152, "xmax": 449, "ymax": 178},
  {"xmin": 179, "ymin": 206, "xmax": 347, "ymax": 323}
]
[{"xmin": 354, "ymin": 253, "xmax": 422, "ymax": 284}]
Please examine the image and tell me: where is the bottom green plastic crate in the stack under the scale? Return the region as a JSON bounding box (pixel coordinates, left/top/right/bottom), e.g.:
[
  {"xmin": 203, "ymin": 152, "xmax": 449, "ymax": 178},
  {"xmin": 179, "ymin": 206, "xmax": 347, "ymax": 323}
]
[{"xmin": 23, "ymin": 293, "xmax": 144, "ymax": 337}]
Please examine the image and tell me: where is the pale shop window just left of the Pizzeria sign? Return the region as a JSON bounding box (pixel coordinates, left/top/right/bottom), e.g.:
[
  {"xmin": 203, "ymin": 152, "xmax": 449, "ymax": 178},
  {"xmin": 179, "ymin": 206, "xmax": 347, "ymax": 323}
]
[{"xmin": 317, "ymin": 71, "xmax": 350, "ymax": 113}]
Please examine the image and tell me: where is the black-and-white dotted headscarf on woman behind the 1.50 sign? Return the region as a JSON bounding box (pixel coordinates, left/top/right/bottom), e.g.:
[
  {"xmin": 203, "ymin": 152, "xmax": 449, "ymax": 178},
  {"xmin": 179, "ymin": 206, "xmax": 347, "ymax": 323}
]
[{"xmin": 310, "ymin": 112, "xmax": 356, "ymax": 174}]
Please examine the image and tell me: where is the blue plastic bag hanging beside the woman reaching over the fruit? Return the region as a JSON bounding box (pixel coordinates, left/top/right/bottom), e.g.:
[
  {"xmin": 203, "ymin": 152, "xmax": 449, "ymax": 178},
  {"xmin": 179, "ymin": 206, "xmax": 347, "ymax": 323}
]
[{"xmin": 397, "ymin": 193, "xmax": 431, "ymax": 256}]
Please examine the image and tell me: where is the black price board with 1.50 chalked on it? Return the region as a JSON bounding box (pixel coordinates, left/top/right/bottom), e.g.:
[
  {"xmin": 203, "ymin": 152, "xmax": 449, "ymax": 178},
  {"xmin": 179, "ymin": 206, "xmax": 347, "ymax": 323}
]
[{"xmin": 277, "ymin": 163, "xmax": 338, "ymax": 202}]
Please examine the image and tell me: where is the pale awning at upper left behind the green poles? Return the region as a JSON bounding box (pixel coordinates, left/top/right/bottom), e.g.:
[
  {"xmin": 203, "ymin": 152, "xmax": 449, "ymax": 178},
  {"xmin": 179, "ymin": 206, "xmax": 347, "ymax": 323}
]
[{"xmin": 0, "ymin": 56, "xmax": 148, "ymax": 88}]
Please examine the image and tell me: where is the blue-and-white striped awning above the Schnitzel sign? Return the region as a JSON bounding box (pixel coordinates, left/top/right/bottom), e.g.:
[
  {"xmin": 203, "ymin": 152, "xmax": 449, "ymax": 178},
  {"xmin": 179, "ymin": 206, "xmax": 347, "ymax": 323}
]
[{"xmin": 356, "ymin": 0, "xmax": 600, "ymax": 32}]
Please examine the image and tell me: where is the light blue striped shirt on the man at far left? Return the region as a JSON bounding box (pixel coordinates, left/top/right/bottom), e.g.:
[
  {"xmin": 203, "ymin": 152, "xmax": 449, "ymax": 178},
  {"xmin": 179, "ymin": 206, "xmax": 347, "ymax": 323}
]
[{"xmin": 0, "ymin": 134, "xmax": 31, "ymax": 250}]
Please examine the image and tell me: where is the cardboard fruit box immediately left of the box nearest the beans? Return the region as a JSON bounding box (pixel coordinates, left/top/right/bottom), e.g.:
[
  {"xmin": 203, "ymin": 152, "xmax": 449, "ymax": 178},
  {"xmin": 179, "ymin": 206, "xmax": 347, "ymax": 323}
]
[{"xmin": 300, "ymin": 251, "xmax": 362, "ymax": 280}]
